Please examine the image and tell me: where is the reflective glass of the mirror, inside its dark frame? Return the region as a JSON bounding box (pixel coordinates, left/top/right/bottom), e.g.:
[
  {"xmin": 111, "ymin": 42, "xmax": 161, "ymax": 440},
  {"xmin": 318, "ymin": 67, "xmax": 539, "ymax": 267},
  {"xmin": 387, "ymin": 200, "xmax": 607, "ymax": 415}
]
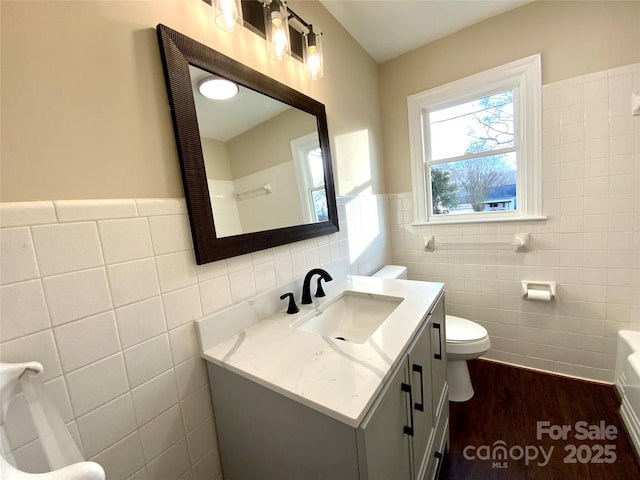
[{"xmin": 189, "ymin": 65, "xmax": 329, "ymax": 237}]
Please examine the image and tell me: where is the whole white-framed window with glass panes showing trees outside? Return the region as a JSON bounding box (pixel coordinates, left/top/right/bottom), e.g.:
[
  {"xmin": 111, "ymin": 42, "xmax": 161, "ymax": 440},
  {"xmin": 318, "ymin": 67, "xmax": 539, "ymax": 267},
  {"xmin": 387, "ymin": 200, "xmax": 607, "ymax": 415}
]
[{"xmin": 407, "ymin": 55, "xmax": 543, "ymax": 224}]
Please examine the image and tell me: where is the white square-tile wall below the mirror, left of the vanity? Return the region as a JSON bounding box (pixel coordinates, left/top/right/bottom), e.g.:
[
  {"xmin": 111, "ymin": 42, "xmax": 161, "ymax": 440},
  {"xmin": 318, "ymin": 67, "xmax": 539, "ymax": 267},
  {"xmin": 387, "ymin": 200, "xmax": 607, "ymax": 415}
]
[{"xmin": 0, "ymin": 194, "xmax": 372, "ymax": 480}]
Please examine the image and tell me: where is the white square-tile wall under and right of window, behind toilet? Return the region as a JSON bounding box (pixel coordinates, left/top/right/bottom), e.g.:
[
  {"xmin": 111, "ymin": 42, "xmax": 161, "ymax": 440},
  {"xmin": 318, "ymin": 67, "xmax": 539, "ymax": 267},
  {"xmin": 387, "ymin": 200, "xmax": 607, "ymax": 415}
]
[{"xmin": 389, "ymin": 64, "xmax": 640, "ymax": 382}]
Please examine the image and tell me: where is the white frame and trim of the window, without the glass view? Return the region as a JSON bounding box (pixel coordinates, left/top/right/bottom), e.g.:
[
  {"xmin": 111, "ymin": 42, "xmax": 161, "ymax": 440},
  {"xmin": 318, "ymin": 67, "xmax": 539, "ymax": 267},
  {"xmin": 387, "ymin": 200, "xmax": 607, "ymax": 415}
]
[{"xmin": 407, "ymin": 54, "xmax": 546, "ymax": 225}]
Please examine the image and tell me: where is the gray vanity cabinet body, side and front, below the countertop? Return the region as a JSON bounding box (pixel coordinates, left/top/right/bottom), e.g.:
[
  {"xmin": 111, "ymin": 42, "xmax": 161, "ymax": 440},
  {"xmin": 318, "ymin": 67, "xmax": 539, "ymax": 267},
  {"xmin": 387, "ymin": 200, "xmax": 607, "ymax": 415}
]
[{"xmin": 208, "ymin": 294, "xmax": 448, "ymax": 480}]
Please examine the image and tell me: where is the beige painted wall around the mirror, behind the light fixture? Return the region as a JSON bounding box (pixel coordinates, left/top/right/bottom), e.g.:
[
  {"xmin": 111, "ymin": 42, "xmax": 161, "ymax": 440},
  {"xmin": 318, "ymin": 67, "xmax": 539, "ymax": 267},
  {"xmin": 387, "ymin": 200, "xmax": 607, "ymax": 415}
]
[{"xmin": 0, "ymin": 0, "xmax": 381, "ymax": 202}]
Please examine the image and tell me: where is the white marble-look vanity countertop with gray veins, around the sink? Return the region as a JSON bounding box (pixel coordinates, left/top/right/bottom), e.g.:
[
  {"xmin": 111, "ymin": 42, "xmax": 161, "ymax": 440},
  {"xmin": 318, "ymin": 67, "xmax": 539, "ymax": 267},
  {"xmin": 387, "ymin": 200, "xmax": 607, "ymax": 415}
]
[{"xmin": 198, "ymin": 276, "xmax": 443, "ymax": 427}]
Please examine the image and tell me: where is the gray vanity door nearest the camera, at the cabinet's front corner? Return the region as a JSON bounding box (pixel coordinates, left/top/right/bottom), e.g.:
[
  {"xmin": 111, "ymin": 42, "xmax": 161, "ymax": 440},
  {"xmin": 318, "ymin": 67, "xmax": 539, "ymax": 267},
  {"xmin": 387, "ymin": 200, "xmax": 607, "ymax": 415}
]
[{"xmin": 357, "ymin": 361, "xmax": 411, "ymax": 480}]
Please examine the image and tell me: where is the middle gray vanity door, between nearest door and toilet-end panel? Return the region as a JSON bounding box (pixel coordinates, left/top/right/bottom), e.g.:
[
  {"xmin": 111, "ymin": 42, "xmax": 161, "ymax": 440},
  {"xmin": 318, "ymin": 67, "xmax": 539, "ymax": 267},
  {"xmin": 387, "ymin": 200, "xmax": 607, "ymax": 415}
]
[{"xmin": 408, "ymin": 322, "xmax": 434, "ymax": 479}]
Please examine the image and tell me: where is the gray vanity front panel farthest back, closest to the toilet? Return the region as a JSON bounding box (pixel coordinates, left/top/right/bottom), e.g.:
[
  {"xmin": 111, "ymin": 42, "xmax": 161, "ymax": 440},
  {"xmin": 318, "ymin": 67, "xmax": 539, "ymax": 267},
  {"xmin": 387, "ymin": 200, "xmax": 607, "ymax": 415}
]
[{"xmin": 429, "ymin": 295, "xmax": 449, "ymax": 422}]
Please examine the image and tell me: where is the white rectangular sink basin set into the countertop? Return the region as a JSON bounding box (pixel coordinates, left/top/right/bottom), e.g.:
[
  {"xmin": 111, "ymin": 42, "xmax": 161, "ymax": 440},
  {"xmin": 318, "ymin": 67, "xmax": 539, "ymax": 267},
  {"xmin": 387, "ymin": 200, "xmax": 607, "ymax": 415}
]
[{"xmin": 291, "ymin": 290, "xmax": 404, "ymax": 343}]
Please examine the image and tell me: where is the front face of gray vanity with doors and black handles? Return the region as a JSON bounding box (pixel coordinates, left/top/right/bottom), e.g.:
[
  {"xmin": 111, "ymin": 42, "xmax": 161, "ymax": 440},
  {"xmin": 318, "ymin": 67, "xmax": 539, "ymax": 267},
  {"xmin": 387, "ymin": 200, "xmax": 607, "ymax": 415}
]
[{"xmin": 358, "ymin": 297, "xmax": 449, "ymax": 480}]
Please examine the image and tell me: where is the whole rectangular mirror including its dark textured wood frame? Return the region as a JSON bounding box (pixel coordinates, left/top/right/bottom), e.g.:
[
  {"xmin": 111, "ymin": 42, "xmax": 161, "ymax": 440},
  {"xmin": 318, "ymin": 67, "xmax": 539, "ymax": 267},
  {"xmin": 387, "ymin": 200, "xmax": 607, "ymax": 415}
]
[{"xmin": 157, "ymin": 25, "xmax": 338, "ymax": 264}]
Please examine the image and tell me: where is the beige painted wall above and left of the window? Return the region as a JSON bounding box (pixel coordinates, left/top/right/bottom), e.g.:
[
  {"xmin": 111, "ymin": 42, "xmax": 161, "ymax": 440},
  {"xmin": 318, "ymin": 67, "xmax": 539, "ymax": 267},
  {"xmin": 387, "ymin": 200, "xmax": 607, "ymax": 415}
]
[{"xmin": 379, "ymin": 0, "xmax": 640, "ymax": 193}]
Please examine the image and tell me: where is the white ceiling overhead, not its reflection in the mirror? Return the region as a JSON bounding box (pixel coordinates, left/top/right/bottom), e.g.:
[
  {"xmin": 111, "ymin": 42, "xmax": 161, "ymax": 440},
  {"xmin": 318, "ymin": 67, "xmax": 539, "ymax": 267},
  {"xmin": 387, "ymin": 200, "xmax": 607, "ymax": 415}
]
[{"xmin": 319, "ymin": 0, "xmax": 532, "ymax": 63}]
